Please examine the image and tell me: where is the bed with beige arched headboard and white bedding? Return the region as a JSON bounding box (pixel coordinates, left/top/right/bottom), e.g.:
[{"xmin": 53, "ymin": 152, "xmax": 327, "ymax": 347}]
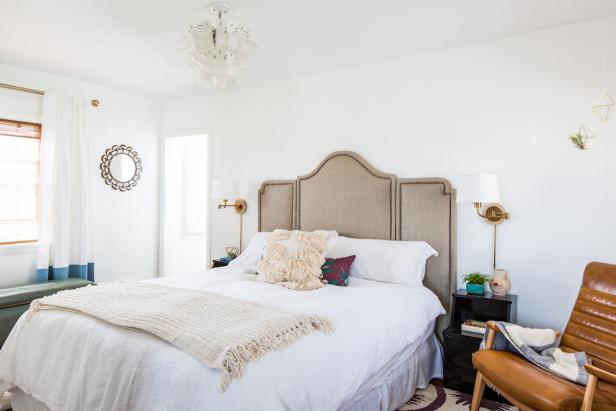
[{"xmin": 0, "ymin": 152, "xmax": 455, "ymax": 411}]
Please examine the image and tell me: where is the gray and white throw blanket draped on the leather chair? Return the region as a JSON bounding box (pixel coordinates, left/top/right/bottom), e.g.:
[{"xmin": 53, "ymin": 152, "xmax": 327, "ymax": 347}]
[{"xmin": 481, "ymin": 321, "xmax": 590, "ymax": 385}]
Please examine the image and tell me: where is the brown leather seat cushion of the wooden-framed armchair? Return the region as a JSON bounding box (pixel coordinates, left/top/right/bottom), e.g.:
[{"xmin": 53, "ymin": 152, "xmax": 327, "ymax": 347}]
[{"xmin": 473, "ymin": 350, "xmax": 616, "ymax": 411}]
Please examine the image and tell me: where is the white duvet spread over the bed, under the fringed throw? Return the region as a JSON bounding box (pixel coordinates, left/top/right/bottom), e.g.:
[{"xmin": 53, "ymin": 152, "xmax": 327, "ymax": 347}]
[{"xmin": 0, "ymin": 267, "xmax": 444, "ymax": 411}]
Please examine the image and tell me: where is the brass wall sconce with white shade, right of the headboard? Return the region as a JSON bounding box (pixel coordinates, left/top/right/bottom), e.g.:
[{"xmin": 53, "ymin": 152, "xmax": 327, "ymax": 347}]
[{"xmin": 457, "ymin": 174, "xmax": 509, "ymax": 270}]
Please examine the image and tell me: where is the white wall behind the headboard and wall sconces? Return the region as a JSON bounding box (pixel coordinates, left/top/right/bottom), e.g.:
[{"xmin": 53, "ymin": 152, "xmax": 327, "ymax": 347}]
[{"xmin": 163, "ymin": 18, "xmax": 616, "ymax": 328}]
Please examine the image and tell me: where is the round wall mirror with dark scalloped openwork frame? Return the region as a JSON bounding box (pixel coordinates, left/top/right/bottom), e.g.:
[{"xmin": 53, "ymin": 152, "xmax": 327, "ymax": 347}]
[{"xmin": 101, "ymin": 144, "xmax": 141, "ymax": 191}]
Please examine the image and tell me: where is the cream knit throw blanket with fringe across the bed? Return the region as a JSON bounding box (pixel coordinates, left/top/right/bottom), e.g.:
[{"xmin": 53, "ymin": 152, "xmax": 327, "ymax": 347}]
[{"xmin": 28, "ymin": 282, "xmax": 333, "ymax": 392}]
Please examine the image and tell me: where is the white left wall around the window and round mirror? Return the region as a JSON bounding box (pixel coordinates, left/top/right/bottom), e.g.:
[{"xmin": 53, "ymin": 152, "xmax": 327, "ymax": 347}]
[{"xmin": 0, "ymin": 65, "xmax": 160, "ymax": 287}]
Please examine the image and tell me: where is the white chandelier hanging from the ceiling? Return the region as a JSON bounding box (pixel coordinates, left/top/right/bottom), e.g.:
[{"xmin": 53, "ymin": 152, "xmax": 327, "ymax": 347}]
[{"xmin": 188, "ymin": 3, "xmax": 257, "ymax": 90}]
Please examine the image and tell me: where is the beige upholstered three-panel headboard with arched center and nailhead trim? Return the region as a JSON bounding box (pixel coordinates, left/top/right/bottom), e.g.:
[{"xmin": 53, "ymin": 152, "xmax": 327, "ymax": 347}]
[{"xmin": 259, "ymin": 151, "xmax": 456, "ymax": 335}]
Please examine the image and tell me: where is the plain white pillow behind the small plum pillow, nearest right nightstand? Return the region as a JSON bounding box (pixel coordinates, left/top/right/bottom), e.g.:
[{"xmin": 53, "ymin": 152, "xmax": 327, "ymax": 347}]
[{"xmin": 325, "ymin": 237, "xmax": 438, "ymax": 286}]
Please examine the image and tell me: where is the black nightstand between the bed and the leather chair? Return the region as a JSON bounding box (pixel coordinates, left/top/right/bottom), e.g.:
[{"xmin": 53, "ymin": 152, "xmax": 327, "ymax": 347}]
[{"xmin": 443, "ymin": 290, "xmax": 518, "ymax": 401}]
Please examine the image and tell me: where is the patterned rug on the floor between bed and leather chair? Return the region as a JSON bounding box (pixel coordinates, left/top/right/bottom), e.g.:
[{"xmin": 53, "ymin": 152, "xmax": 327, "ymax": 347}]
[{"xmin": 398, "ymin": 380, "xmax": 517, "ymax": 411}]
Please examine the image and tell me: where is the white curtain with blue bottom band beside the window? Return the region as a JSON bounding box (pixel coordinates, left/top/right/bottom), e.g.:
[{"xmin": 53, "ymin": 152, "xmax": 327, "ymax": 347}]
[{"xmin": 36, "ymin": 93, "xmax": 94, "ymax": 282}]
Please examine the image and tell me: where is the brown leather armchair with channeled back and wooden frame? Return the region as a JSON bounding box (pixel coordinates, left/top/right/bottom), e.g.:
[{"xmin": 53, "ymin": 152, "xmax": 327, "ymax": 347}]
[{"xmin": 471, "ymin": 263, "xmax": 616, "ymax": 411}]
